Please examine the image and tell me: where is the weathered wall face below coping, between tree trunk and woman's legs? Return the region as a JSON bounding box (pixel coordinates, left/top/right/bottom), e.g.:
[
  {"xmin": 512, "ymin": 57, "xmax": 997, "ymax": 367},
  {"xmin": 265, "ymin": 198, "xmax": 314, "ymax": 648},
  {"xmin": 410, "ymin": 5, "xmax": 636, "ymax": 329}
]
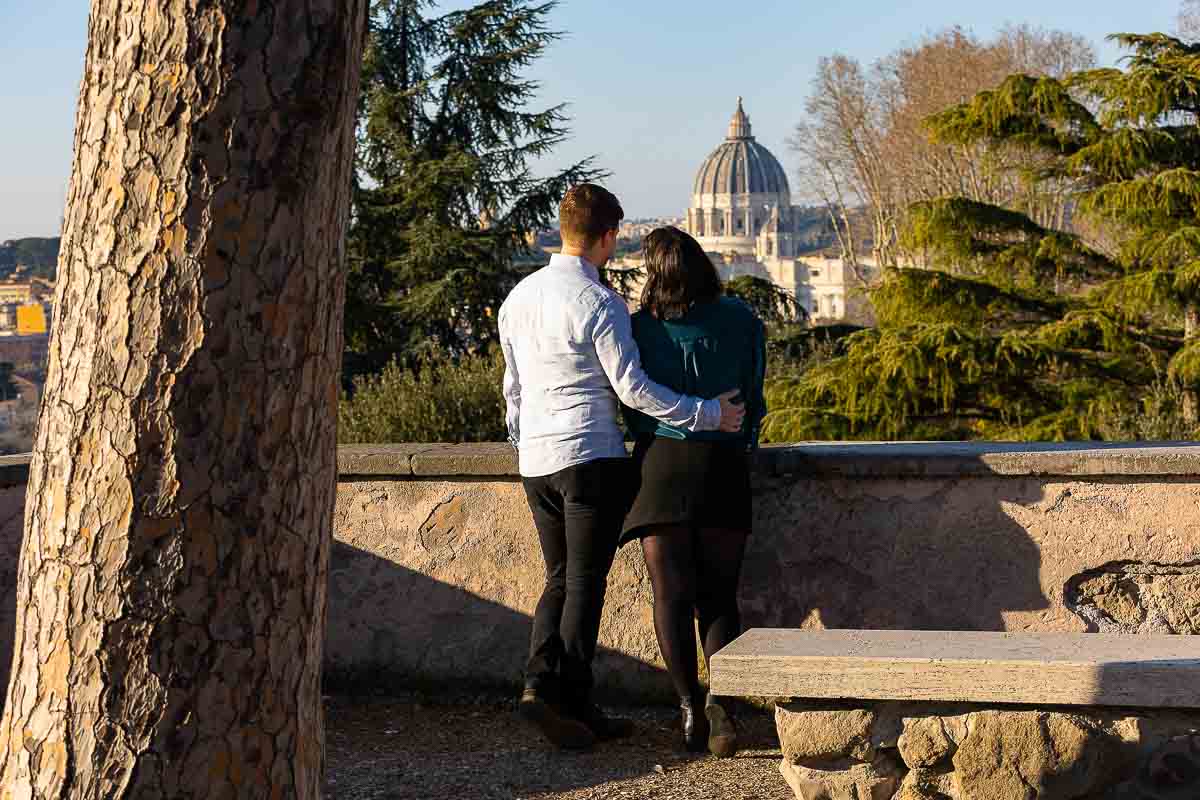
[{"xmin": 325, "ymin": 479, "xmax": 666, "ymax": 696}]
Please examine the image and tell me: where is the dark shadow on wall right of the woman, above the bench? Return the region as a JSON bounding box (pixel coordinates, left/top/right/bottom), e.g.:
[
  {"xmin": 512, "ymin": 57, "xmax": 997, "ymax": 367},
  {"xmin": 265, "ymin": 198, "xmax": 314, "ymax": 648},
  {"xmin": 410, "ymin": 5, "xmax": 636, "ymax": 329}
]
[{"xmin": 742, "ymin": 479, "xmax": 1050, "ymax": 631}]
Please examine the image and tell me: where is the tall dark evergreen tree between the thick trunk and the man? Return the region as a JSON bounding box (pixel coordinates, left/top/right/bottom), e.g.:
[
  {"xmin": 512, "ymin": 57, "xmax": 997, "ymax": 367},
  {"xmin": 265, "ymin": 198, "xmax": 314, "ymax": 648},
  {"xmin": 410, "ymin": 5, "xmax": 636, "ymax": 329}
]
[{"xmin": 346, "ymin": 0, "xmax": 600, "ymax": 379}]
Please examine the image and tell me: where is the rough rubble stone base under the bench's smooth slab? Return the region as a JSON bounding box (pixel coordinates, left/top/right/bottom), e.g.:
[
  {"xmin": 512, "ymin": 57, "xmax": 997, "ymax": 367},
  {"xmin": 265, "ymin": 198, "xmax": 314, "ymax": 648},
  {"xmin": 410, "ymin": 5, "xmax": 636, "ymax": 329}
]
[{"xmin": 775, "ymin": 700, "xmax": 1200, "ymax": 800}]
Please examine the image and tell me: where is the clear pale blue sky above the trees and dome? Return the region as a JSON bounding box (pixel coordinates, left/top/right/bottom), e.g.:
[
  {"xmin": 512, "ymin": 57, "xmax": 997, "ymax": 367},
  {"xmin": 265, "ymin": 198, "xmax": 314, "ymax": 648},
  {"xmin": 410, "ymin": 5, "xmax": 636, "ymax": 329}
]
[{"xmin": 0, "ymin": 0, "xmax": 1178, "ymax": 241}]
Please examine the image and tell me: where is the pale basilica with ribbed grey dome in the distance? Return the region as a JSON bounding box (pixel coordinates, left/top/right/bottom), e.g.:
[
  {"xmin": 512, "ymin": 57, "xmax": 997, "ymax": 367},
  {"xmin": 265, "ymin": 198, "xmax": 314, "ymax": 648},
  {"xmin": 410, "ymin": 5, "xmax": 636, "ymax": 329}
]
[{"xmin": 685, "ymin": 98, "xmax": 852, "ymax": 321}]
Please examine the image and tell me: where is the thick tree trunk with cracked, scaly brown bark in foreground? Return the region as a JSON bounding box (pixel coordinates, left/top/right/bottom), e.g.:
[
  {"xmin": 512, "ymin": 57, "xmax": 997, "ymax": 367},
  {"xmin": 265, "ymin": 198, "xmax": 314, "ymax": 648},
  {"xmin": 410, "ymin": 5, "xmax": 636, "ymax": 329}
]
[{"xmin": 0, "ymin": 0, "xmax": 366, "ymax": 800}]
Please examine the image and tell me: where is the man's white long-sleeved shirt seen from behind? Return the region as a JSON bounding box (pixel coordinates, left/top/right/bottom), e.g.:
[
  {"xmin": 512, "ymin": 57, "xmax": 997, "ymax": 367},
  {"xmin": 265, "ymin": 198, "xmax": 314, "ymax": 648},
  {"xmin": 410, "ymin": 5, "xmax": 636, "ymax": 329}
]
[{"xmin": 499, "ymin": 255, "xmax": 721, "ymax": 477}]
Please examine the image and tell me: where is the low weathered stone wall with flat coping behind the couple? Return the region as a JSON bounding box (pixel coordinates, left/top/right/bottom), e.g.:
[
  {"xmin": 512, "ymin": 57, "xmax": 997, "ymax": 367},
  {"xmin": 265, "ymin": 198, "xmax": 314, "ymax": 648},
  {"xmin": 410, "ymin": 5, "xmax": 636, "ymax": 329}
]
[{"xmin": 0, "ymin": 444, "xmax": 1200, "ymax": 698}]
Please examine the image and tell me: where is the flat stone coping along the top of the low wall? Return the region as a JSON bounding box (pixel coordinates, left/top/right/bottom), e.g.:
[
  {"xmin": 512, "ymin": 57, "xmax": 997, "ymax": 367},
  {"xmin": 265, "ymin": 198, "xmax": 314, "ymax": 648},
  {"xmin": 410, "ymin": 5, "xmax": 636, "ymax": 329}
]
[{"xmin": 337, "ymin": 441, "xmax": 1200, "ymax": 477}]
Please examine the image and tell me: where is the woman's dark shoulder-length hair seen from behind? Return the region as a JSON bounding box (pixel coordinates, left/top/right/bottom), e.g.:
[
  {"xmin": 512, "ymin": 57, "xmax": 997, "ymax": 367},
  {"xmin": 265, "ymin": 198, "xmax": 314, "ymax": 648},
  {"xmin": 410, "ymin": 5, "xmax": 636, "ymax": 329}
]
[{"xmin": 642, "ymin": 228, "xmax": 721, "ymax": 319}]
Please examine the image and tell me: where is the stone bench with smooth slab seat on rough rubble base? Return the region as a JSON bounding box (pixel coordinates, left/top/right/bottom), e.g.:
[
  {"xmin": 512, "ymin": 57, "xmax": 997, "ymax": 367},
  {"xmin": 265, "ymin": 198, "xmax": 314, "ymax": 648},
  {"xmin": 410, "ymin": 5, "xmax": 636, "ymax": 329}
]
[{"xmin": 710, "ymin": 628, "xmax": 1200, "ymax": 800}]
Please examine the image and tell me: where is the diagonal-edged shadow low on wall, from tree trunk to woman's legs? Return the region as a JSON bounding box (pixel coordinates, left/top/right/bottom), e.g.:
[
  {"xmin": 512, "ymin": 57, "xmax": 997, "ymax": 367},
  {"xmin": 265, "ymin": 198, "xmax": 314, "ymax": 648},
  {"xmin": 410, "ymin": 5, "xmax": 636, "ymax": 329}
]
[{"xmin": 325, "ymin": 542, "xmax": 670, "ymax": 699}]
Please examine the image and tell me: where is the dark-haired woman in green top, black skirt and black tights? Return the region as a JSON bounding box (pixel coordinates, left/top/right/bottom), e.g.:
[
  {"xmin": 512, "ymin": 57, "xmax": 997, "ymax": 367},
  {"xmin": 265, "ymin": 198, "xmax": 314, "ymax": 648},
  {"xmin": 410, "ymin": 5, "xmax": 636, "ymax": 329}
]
[{"xmin": 622, "ymin": 228, "xmax": 766, "ymax": 758}]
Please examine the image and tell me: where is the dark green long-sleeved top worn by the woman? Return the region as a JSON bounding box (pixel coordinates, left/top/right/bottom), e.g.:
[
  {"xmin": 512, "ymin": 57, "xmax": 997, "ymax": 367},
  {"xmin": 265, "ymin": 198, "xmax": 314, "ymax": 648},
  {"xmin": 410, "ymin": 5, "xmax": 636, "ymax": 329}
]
[{"xmin": 625, "ymin": 297, "xmax": 767, "ymax": 449}]
